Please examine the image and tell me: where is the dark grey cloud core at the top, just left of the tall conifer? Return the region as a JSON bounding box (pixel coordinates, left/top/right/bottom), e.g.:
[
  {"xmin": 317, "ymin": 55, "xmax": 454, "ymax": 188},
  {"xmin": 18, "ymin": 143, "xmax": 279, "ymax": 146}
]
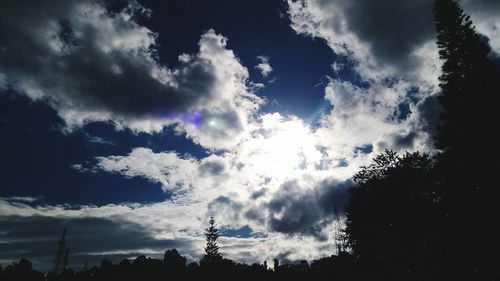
[{"xmin": 346, "ymin": 0, "xmax": 434, "ymax": 68}]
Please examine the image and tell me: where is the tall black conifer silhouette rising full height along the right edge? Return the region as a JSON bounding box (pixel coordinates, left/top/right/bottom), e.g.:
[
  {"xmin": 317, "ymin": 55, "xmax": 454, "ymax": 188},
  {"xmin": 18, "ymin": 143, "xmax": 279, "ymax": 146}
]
[{"xmin": 434, "ymin": 0, "xmax": 500, "ymax": 280}]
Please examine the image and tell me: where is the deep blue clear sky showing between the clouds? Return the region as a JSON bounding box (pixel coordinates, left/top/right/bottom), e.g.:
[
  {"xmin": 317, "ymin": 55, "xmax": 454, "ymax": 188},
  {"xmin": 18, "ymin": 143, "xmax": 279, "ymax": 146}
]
[{"xmin": 1, "ymin": 1, "xmax": 335, "ymax": 205}]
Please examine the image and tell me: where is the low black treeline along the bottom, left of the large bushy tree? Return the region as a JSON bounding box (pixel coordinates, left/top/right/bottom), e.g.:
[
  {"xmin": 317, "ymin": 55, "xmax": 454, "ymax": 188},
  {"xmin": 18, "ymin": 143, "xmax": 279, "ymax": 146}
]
[{"xmin": 0, "ymin": 253, "xmax": 362, "ymax": 281}]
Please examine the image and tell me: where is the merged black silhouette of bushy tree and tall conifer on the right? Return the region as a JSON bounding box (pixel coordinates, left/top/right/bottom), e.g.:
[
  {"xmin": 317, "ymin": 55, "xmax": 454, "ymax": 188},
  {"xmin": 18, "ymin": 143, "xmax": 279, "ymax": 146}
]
[{"xmin": 346, "ymin": 0, "xmax": 500, "ymax": 280}]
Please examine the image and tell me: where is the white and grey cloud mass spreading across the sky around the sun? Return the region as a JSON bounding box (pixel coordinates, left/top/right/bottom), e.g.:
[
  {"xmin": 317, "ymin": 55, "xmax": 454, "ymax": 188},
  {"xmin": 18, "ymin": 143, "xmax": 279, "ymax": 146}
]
[{"xmin": 0, "ymin": 0, "xmax": 496, "ymax": 270}]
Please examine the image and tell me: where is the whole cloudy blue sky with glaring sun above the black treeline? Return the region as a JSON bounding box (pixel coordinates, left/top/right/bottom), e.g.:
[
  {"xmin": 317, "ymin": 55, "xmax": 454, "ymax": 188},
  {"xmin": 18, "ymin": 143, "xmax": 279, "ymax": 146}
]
[{"xmin": 0, "ymin": 0, "xmax": 500, "ymax": 270}]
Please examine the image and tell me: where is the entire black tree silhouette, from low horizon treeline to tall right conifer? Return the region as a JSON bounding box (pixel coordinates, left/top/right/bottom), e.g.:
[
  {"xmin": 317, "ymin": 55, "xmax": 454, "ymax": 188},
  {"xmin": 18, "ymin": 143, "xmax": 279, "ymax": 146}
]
[{"xmin": 0, "ymin": 0, "xmax": 500, "ymax": 280}]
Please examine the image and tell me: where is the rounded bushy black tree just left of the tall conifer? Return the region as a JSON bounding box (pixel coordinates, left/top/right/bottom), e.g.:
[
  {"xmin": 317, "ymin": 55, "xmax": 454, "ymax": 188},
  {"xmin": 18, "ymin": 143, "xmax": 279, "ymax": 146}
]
[{"xmin": 345, "ymin": 150, "xmax": 438, "ymax": 280}]
